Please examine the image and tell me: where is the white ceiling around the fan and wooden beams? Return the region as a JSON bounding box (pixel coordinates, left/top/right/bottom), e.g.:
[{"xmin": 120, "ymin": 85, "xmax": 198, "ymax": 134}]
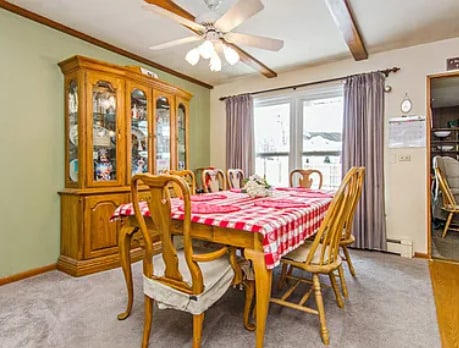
[{"xmin": 9, "ymin": 0, "xmax": 459, "ymax": 85}]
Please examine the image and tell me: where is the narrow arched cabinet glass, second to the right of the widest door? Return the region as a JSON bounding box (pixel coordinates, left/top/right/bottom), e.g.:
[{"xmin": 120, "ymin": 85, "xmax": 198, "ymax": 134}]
[{"xmin": 155, "ymin": 95, "xmax": 171, "ymax": 174}]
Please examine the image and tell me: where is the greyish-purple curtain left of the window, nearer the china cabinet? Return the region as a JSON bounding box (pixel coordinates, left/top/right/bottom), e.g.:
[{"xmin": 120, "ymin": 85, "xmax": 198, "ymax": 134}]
[{"xmin": 225, "ymin": 94, "xmax": 255, "ymax": 176}]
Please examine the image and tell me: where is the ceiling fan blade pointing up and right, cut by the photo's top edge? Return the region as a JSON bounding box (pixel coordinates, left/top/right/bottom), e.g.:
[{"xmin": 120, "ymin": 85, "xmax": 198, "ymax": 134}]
[{"xmin": 215, "ymin": 0, "xmax": 264, "ymax": 33}]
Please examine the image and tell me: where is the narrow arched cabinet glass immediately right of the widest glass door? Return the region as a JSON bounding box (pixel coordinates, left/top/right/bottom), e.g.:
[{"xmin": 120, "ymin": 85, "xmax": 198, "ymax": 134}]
[{"xmin": 130, "ymin": 88, "xmax": 150, "ymax": 175}]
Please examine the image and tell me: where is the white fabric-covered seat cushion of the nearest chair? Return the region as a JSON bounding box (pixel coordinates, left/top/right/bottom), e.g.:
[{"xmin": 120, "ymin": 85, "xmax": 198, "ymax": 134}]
[{"xmin": 143, "ymin": 250, "xmax": 234, "ymax": 314}]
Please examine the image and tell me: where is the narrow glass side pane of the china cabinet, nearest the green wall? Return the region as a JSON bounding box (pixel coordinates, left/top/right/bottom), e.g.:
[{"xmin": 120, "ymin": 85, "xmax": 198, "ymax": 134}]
[{"xmin": 67, "ymin": 80, "xmax": 79, "ymax": 183}]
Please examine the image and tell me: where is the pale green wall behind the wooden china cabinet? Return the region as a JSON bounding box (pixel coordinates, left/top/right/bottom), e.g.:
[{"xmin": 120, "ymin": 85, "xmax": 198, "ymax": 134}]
[{"xmin": 0, "ymin": 9, "xmax": 210, "ymax": 278}]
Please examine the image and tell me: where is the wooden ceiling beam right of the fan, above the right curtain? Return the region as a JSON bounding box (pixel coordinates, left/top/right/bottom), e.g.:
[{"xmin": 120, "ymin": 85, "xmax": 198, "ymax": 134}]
[{"xmin": 326, "ymin": 0, "xmax": 368, "ymax": 60}]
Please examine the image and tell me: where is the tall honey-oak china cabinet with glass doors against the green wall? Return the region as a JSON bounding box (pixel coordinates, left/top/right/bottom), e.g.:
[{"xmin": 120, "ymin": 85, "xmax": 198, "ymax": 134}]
[{"xmin": 57, "ymin": 56, "xmax": 191, "ymax": 276}]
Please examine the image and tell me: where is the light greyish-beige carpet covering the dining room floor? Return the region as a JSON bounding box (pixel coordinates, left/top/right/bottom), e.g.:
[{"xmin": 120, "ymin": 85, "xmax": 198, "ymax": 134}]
[{"xmin": 0, "ymin": 250, "xmax": 440, "ymax": 348}]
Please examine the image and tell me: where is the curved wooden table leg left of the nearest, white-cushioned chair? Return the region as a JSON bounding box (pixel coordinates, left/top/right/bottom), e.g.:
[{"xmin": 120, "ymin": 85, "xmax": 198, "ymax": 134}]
[{"xmin": 118, "ymin": 226, "xmax": 138, "ymax": 320}]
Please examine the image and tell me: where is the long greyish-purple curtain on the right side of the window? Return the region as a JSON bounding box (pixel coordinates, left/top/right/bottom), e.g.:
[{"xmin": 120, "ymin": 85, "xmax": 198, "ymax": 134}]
[{"xmin": 342, "ymin": 72, "xmax": 386, "ymax": 250}]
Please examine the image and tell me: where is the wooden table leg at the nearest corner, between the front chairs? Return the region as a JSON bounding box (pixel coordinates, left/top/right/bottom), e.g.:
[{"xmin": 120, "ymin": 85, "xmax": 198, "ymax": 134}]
[{"xmin": 244, "ymin": 249, "xmax": 272, "ymax": 348}]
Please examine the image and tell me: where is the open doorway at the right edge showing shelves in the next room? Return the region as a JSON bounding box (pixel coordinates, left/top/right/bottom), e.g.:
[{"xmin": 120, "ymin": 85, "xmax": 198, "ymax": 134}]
[{"xmin": 427, "ymin": 71, "xmax": 459, "ymax": 261}]
